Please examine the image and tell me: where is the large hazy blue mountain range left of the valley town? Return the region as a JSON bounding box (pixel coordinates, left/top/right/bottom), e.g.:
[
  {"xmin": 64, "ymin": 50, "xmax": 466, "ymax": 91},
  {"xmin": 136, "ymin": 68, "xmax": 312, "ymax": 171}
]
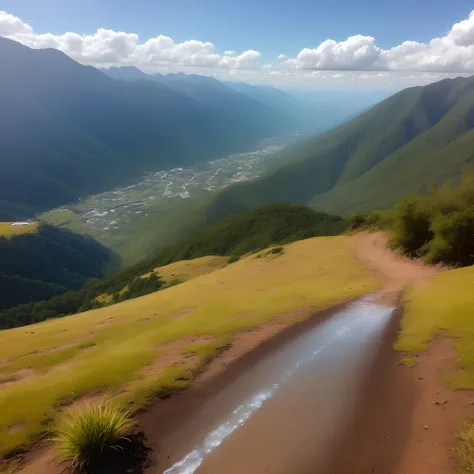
[{"xmin": 0, "ymin": 38, "xmax": 294, "ymax": 220}]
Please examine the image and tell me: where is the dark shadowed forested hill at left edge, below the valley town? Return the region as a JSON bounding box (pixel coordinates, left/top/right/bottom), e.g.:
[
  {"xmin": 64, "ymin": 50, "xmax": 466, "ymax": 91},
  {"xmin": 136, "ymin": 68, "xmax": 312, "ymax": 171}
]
[{"xmin": 0, "ymin": 224, "xmax": 117, "ymax": 310}]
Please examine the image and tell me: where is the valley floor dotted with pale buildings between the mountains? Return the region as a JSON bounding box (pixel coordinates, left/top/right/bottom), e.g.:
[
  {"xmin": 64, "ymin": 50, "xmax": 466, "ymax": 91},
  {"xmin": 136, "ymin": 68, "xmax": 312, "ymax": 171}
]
[{"xmin": 37, "ymin": 133, "xmax": 304, "ymax": 260}]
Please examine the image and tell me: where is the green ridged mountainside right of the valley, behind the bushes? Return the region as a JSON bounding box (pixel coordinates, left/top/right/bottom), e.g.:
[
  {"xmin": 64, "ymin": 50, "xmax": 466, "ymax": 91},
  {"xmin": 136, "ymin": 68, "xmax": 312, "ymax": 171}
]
[{"xmin": 200, "ymin": 78, "xmax": 474, "ymax": 217}]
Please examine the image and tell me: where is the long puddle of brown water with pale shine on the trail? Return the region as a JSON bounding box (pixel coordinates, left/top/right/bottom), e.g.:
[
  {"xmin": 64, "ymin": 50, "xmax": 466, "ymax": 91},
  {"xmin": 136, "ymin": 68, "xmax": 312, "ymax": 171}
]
[{"xmin": 158, "ymin": 297, "xmax": 395, "ymax": 474}]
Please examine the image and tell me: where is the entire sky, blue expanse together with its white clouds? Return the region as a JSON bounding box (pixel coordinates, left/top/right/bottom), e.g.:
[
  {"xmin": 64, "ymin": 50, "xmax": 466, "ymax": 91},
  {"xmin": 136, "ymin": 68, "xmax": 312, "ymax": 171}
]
[{"xmin": 0, "ymin": 0, "xmax": 474, "ymax": 90}]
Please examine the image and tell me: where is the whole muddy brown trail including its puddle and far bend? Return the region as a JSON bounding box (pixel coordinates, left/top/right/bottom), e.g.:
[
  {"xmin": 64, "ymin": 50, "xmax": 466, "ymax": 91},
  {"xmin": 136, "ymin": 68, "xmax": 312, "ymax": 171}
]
[{"xmin": 141, "ymin": 233, "xmax": 439, "ymax": 474}]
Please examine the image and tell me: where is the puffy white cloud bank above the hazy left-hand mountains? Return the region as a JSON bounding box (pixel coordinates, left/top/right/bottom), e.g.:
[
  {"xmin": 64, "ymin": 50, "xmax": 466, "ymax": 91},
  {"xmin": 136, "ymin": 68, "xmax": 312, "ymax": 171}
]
[{"xmin": 0, "ymin": 12, "xmax": 261, "ymax": 69}]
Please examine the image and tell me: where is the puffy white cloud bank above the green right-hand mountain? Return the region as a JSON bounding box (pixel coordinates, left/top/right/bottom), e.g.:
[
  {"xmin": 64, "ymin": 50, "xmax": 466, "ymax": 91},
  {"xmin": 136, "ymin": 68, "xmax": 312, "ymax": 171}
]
[{"xmin": 282, "ymin": 11, "xmax": 474, "ymax": 72}]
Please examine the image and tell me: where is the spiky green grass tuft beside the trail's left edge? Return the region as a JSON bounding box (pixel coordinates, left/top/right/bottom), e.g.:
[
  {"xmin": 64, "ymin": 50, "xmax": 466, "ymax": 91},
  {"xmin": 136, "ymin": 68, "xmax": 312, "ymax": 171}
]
[{"xmin": 54, "ymin": 402, "xmax": 134, "ymax": 470}]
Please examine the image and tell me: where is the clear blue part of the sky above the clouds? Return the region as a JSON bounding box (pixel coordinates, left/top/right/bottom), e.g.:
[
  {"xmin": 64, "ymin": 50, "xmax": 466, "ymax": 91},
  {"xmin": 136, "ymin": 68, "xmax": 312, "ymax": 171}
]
[{"xmin": 0, "ymin": 0, "xmax": 474, "ymax": 55}]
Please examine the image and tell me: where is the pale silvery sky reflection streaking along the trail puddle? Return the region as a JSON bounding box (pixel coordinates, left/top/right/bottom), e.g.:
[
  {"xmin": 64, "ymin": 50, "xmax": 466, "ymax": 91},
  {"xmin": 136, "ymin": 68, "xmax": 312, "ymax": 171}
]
[{"xmin": 164, "ymin": 297, "xmax": 394, "ymax": 474}]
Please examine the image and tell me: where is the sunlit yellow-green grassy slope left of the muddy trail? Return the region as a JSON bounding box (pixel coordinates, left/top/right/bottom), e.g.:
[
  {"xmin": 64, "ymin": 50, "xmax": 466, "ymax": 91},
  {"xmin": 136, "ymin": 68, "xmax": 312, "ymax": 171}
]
[{"xmin": 0, "ymin": 237, "xmax": 377, "ymax": 453}]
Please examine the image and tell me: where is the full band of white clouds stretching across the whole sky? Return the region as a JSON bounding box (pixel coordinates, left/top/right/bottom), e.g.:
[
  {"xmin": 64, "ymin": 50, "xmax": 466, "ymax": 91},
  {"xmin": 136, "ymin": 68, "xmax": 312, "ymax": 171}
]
[{"xmin": 0, "ymin": 11, "xmax": 474, "ymax": 89}]
